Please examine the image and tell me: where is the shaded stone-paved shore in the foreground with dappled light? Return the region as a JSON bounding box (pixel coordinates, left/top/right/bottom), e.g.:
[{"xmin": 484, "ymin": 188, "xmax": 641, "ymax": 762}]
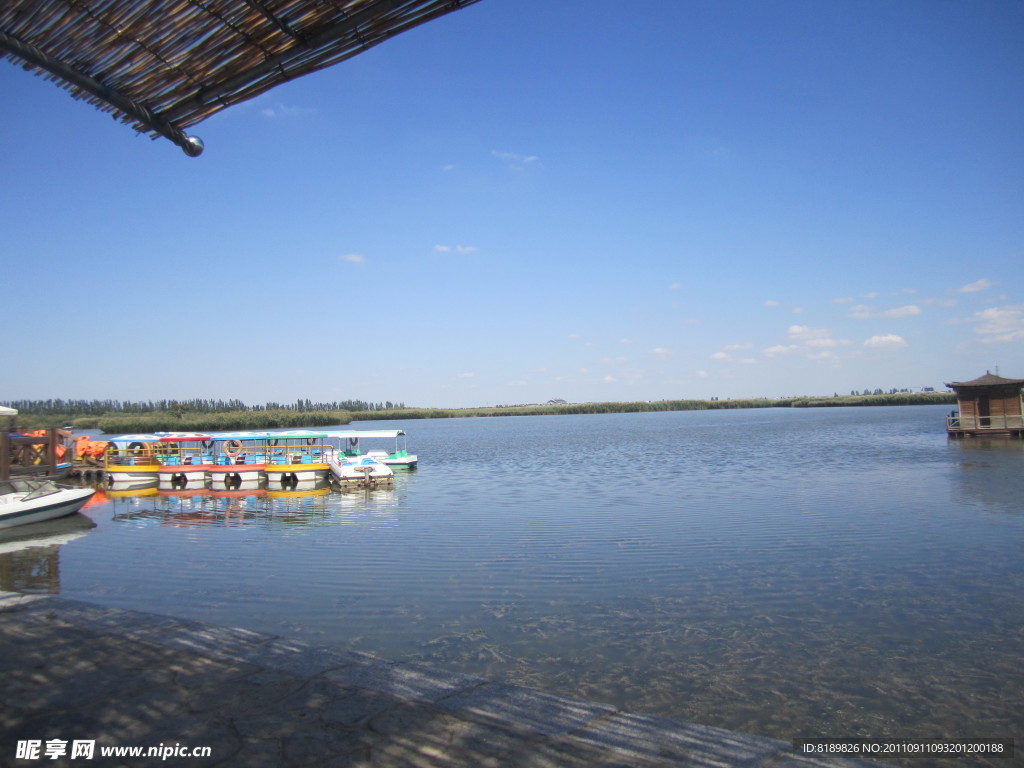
[{"xmin": 0, "ymin": 592, "xmax": 874, "ymax": 768}]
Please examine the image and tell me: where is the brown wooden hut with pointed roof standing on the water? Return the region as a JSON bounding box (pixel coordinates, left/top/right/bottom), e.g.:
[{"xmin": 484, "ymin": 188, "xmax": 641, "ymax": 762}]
[{"xmin": 946, "ymin": 372, "xmax": 1024, "ymax": 437}]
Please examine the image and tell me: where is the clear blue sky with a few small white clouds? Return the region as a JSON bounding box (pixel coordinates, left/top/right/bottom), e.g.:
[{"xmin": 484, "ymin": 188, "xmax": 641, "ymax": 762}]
[{"xmin": 0, "ymin": 0, "xmax": 1024, "ymax": 408}]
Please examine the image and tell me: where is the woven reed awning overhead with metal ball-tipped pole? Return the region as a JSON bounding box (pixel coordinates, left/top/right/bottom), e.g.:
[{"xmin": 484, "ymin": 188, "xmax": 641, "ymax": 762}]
[{"xmin": 0, "ymin": 0, "xmax": 477, "ymax": 156}]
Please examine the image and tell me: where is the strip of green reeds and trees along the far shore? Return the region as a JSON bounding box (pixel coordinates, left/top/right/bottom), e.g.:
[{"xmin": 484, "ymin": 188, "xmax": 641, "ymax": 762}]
[{"xmin": 0, "ymin": 392, "xmax": 955, "ymax": 434}]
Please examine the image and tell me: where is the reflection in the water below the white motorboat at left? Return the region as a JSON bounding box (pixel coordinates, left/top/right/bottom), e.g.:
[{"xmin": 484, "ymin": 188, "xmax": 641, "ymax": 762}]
[{"xmin": 0, "ymin": 512, "xmax": 96, "ymax": 595}]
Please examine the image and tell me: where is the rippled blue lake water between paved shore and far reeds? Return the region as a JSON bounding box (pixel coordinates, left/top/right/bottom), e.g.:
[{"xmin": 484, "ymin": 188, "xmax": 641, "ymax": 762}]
[{"xmin": 0, "ymin": 407, "xmax": 1024, "ymax": 766}]
